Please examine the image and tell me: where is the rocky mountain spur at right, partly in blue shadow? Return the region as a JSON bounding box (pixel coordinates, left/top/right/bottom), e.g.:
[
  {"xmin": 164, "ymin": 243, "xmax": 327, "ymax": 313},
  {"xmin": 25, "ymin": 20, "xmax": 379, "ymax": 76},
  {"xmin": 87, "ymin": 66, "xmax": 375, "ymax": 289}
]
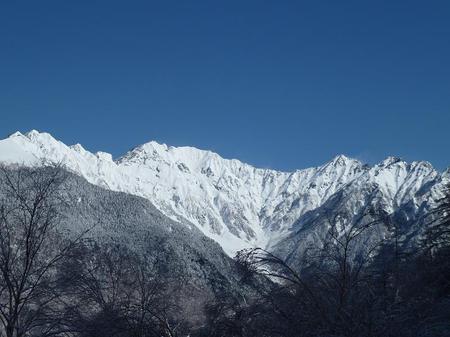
[{"xmin": 269, "ymin": 157, "xmax": 449, "ymax": 265}]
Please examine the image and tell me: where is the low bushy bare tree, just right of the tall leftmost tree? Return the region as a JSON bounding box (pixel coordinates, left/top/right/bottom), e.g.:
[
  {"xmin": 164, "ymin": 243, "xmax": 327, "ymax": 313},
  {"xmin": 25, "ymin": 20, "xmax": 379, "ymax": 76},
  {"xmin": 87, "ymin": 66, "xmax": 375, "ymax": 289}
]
[{"xmin": 66, "ymin": 242, "xmax": 184, "ymax": 337}]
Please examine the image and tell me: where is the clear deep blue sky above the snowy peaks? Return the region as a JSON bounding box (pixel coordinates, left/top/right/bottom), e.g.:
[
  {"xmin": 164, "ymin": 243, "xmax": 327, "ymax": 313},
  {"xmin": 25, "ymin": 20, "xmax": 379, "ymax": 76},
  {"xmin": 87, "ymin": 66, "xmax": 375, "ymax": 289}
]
[{"xmin": 0, "ymin": 0, "xmax": 450, "ymax": 170}]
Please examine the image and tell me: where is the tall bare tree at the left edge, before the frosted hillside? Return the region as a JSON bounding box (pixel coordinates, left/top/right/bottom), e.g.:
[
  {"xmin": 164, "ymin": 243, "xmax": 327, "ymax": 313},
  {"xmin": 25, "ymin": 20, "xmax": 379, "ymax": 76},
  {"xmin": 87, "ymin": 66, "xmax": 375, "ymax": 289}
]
[{"xmin": 0, "ymin": 166, "xmax": 83, "ymax": 337}]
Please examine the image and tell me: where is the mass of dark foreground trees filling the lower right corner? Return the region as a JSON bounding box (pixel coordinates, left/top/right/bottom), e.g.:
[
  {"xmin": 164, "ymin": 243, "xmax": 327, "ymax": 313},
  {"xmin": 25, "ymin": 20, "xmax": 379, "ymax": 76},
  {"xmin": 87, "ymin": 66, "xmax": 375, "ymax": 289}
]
[{"xmin": 199, "ymin": 185, "xmax": 450, "ymax": 337}]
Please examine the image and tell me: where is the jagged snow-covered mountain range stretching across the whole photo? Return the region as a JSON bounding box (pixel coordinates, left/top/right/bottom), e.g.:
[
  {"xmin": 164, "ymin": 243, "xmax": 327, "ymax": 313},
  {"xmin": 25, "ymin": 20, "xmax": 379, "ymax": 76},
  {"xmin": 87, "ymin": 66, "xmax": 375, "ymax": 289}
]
[{"xmin": 0, "ymin": 130, "xmax": 450, "ymax": 255}]
